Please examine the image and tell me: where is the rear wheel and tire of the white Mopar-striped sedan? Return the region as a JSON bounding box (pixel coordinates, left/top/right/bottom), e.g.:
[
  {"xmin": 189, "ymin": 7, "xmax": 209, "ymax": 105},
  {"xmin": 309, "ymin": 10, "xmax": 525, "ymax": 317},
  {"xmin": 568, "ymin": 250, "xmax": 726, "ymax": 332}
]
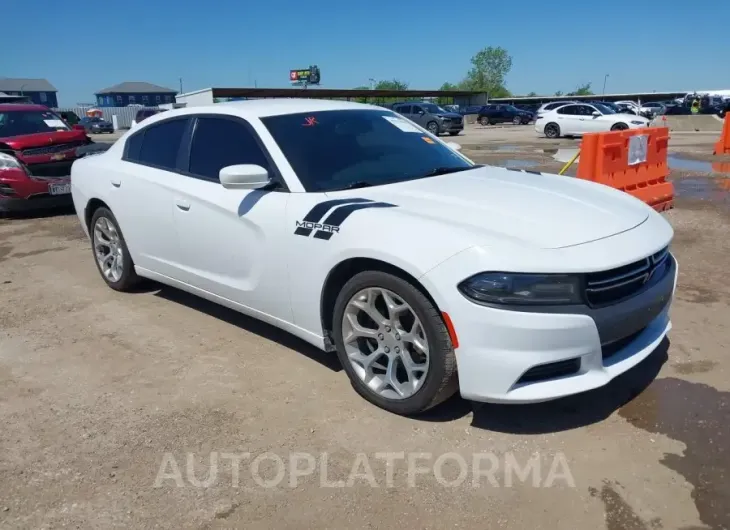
[{"xmin": 89, "ymin": 207, "xmax": 140, "ymax": 291}]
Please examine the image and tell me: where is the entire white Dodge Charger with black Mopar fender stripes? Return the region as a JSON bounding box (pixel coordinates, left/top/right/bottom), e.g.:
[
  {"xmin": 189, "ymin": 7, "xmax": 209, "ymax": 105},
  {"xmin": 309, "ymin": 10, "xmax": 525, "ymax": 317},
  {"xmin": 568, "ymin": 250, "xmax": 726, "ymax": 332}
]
[{"xmin": 71, "ymin": 99, "xmax": 677, "ymax": 414}]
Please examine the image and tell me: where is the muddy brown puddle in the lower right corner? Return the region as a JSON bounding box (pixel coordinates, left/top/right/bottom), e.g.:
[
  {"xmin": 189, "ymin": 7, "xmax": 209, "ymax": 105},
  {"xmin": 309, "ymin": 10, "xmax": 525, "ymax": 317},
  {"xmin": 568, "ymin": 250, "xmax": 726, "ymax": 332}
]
[{"xmin": 619, "ymin": 377, "xmax": 730, "ymax": 528}]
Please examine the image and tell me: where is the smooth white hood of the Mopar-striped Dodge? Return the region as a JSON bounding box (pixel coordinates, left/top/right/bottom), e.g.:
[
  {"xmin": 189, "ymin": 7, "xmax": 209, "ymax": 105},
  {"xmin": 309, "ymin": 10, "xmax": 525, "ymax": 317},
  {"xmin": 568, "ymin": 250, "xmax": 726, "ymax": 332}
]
[{"xmin": 328, "ymin": 166, "xmax": 651, "ymax": 249}]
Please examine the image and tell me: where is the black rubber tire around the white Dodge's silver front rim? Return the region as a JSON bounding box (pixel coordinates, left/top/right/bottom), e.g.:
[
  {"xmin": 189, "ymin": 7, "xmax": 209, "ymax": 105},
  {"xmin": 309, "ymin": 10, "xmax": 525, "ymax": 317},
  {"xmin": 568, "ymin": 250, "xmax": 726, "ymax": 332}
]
[{"xmin": 333, "ymin": 271, "xmax": 458, "ymax": 415}]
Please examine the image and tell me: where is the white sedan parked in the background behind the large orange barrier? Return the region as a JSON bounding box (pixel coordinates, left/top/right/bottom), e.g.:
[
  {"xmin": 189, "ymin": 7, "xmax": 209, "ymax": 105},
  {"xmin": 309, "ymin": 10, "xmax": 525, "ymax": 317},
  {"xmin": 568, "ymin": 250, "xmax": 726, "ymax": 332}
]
[{"xmin": 535, "ymin": 103, "xmax": 649, "ymax": 138}]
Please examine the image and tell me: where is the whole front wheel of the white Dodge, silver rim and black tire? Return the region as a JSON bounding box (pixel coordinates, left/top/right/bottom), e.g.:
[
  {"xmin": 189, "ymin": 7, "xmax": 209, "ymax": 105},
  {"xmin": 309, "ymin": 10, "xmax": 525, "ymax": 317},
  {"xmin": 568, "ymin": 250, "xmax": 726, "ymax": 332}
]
[{"xmin": 333, "ymin": 271, "xmax": 458, "ymax": 415}]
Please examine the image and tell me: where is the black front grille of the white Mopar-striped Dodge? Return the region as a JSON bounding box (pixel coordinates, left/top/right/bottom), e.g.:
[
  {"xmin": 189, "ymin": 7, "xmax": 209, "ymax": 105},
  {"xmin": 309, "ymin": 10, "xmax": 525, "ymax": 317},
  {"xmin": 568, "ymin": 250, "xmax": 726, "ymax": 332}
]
[{"xmin": 585, "ymin": 248, "xmax": 671, "ymax": 307}]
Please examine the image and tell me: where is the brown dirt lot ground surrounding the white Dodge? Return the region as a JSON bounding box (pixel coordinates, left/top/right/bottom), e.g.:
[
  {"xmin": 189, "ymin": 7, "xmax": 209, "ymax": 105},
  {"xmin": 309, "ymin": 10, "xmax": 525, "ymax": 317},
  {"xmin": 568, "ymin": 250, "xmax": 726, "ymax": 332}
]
[{"xmin": 0, "ymin": 128, "xmax": 730, "ymax": 530}]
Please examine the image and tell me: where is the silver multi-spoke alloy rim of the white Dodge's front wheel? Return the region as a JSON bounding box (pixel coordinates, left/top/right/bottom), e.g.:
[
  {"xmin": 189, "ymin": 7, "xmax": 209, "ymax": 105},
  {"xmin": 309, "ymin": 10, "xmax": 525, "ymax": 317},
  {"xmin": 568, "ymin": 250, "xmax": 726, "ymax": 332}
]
[{"xmin": 342, "ymin": 287, "xmax": 430, "ymax": 400}]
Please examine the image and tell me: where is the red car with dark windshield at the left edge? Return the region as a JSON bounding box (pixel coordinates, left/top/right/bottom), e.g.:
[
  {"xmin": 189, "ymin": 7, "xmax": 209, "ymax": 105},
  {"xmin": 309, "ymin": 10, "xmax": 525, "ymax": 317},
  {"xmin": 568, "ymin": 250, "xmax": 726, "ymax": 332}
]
[{"xmin": 0, "ymin": 103, "xmax": 92, "ymax": 212}]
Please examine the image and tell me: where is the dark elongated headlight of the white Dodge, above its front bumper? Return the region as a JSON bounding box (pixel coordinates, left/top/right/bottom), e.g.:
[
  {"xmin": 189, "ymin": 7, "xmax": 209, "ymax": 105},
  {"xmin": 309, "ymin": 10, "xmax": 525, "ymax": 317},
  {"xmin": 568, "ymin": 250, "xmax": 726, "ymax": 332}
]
[{"xmin": 459, "ymin": 272, "xmax": 582, "ymax": 305}]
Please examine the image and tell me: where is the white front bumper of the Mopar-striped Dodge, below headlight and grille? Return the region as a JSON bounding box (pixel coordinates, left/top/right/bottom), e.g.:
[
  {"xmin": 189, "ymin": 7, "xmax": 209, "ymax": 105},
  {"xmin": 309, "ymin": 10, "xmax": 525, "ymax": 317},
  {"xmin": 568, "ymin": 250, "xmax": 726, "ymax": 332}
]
[{"xmin": 424, "ymin": 257, "xmax": 677, "ymax": 403}]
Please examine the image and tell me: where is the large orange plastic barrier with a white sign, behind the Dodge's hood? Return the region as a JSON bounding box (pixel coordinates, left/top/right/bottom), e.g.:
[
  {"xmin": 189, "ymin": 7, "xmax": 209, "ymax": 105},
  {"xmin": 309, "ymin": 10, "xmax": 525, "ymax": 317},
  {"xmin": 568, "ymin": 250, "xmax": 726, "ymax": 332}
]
[{"xmin": 577, "ymin": 127, "xmax": 674, "ymax": 212}]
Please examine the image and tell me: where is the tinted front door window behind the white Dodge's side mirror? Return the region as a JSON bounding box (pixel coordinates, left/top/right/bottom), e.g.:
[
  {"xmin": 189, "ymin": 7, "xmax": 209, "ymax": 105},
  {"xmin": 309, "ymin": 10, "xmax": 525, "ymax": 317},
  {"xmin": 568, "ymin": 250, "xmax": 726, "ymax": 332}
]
[{"xmin": 190, "ymin": 118, "xmax": 270, "ymax": 180}]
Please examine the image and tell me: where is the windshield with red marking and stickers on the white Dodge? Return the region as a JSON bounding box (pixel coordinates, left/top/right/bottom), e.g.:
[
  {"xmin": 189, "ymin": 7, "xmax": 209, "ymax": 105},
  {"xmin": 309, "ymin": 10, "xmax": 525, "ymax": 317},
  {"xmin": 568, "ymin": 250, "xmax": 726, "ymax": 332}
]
[{"xmin": 261, "ymin": 110, "xmax": 475, "ymax": 192}]
